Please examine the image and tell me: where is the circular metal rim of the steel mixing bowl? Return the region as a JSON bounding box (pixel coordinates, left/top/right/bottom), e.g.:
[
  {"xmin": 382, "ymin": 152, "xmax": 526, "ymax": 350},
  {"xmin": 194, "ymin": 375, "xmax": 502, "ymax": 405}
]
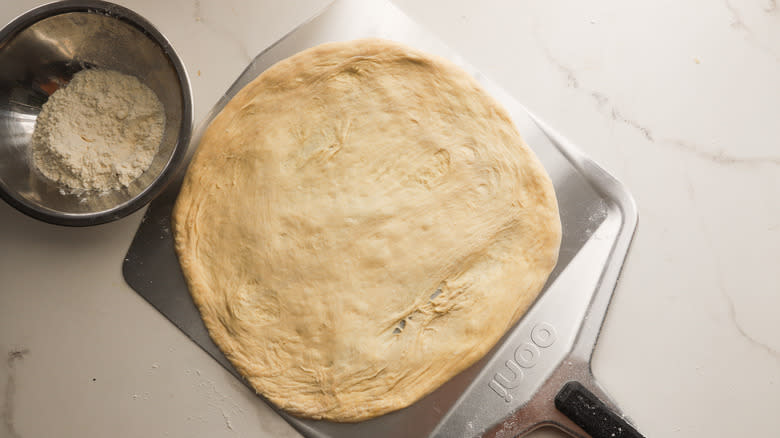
[{"xmin": 0, "ymin": 0, "xmax": 193, "ymax": 227}]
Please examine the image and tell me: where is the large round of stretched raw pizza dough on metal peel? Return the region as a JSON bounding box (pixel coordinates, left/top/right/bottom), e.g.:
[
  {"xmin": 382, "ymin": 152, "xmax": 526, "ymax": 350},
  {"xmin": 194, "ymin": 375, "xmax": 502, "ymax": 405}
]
[{"xmin": 173, "ymin": 40, "xmax": 561, "ymax": 421}]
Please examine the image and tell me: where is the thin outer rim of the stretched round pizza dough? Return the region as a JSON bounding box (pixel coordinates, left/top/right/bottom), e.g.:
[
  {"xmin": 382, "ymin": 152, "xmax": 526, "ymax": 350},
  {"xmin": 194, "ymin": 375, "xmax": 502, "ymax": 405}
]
[{"xmin": 171, "ymin": 39, "xmax": 561, "ymax": 422}]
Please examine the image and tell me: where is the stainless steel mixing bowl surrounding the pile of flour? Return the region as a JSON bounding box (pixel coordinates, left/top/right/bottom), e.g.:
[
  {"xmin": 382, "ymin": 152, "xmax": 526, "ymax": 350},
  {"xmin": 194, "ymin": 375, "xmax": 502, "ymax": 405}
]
[{"xmin": 0, "ymin": 0, "xmax": 192, "ymax": 226}]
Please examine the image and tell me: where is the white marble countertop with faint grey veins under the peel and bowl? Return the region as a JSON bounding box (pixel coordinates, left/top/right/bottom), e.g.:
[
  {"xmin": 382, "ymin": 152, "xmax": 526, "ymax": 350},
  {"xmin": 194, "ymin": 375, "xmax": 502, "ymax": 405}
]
[{"xmin": 0, "ymin": 0, "xmax": 780, "ymax": 438}]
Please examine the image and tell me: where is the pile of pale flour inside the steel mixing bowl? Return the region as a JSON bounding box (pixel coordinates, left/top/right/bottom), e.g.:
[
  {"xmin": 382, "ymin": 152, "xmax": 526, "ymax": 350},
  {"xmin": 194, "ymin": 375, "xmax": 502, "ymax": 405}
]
[{"xmin": 32, "ymin": 69, "xmax": 165, "ymax": 192}]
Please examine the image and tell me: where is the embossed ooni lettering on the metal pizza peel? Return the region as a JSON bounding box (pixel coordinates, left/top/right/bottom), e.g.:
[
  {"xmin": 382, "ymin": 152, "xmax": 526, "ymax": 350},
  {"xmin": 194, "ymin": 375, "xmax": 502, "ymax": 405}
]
[{"xmin": 488, "ymin": 322, "xmax": 557, "ymax": 403}]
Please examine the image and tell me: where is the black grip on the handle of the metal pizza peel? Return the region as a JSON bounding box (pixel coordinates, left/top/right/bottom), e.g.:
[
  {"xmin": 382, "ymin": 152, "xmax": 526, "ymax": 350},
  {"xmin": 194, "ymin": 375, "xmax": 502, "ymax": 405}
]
[{"xmin": 555, "ymin": 381, "xmax": 644, "ymax": 438}]
